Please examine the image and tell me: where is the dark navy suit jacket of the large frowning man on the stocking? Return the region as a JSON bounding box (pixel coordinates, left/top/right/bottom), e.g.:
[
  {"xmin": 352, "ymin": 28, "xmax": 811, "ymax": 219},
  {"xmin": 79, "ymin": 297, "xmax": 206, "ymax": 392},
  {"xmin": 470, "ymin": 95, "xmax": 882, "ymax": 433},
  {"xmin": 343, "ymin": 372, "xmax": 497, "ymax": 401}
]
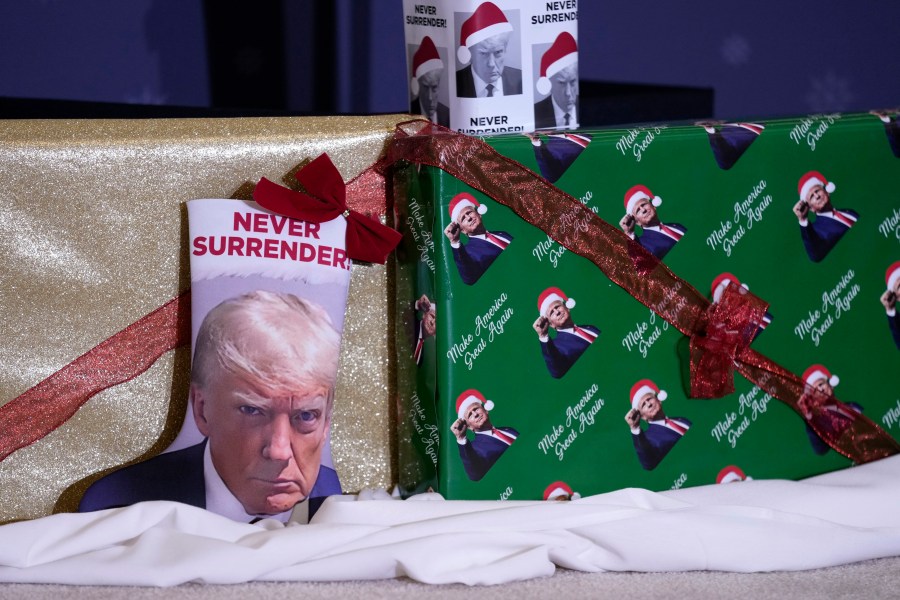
[{"xmin": 78, "ymin": 440, "xmax": 341, "ymax": 517}]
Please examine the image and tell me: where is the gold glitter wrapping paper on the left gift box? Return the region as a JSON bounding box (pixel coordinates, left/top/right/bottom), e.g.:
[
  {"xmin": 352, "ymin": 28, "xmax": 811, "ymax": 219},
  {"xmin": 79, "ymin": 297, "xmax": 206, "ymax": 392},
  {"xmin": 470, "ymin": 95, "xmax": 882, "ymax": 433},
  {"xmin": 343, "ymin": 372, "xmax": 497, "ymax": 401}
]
[{"xmin": 0, "ymin": 115, "xmax": 408, "ymax": 522}]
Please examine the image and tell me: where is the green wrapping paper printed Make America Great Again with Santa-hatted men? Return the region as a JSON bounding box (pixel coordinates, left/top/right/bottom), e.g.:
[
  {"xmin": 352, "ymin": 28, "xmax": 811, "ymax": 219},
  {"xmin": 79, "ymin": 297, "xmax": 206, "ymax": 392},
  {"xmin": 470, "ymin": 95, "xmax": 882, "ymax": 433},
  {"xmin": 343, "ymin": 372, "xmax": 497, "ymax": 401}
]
[{"xmin": 396, "ymin": 114, "xmax": 900, "ymax": 499}]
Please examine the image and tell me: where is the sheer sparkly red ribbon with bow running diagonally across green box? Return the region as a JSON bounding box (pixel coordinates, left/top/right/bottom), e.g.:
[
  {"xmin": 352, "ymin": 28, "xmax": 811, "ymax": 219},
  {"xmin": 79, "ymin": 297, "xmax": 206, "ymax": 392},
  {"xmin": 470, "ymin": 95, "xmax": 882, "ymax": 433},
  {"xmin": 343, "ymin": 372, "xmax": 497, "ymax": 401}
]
[{"xmin": 388, "ymin": 121, "xmax": 900, "ymax": 464}]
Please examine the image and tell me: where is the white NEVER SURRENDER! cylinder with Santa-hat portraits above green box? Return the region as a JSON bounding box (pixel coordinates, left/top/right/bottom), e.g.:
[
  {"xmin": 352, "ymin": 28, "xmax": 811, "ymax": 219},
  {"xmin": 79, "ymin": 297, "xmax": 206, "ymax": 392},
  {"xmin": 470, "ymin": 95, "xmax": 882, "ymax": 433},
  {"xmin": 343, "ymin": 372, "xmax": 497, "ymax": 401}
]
[{"xmin": 403, "ymin": 0, "xmax": 579, "ymax": 135}]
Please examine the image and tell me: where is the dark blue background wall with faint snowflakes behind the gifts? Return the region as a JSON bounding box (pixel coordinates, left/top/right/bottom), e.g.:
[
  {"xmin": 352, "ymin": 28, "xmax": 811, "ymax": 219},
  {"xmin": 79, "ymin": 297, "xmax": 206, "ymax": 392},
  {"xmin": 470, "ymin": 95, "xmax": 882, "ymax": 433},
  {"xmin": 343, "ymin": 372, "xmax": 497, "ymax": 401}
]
[{"xmin": 0, "ymin": 0, "xmax": 900, "ymax": 118}]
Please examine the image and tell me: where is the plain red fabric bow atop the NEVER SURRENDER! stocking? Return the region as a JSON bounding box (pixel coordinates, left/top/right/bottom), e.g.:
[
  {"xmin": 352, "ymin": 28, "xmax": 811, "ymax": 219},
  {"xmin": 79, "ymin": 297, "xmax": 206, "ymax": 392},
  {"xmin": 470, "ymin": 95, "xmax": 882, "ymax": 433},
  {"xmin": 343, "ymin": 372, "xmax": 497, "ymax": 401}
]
[{"xmin": 253, "ymin": 154, "xmax": 403, "ymax": 264}]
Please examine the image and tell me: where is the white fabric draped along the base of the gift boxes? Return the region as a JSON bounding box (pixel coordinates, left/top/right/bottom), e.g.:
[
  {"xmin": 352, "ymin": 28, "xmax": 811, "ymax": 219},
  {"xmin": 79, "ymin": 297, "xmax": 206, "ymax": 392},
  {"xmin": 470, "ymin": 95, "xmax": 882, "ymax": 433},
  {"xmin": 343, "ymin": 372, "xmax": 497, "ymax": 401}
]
[{"xmin": 0, "ymin": 456, "xmax": 900, "ymax": 586}]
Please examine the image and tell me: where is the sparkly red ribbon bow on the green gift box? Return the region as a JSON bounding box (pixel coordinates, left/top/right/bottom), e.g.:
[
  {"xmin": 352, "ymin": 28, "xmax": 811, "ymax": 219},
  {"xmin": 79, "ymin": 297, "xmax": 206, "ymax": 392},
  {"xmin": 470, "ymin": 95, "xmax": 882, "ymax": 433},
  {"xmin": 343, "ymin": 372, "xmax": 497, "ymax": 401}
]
[{"xmin": 691, "ymin": 284, "xmax": 769, "ymax": 398}]
